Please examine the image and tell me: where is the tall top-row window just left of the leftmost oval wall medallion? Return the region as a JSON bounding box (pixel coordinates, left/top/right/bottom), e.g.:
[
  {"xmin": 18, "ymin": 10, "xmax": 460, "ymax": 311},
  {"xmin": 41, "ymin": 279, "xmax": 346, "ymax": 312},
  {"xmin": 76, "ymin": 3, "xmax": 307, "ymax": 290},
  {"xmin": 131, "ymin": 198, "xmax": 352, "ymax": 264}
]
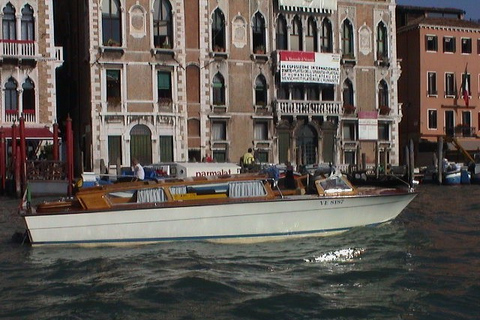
[{"xmin": 102, "ymin": 0, "xmax": 122, "ymax": 46}]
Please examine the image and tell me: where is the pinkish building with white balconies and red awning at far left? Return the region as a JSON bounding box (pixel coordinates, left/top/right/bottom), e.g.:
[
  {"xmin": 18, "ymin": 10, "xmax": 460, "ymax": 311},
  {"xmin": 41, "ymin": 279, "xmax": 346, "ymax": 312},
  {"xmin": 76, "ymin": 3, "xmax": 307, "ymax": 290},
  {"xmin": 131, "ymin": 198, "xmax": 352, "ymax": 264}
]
[{"xmin": 0, "ymin": 0, "xmax": 63, "ymax": 156}]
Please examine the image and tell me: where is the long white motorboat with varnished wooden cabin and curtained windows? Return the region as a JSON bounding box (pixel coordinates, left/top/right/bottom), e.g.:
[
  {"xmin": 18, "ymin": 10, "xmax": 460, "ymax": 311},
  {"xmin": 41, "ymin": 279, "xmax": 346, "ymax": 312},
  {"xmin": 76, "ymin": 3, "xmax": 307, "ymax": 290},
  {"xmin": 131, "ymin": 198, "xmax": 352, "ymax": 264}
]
[{"xmin": 20, "ymin": 174, "xmax": 416, "ymax": 245}]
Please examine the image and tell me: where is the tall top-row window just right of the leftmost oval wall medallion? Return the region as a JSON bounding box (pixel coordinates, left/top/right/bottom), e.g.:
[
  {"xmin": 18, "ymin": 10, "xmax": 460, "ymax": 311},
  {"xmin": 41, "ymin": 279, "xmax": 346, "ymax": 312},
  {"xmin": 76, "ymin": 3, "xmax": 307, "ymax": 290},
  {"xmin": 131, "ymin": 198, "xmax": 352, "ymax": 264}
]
[{"xmin": 153, "ymin": 0, "xmax": 173, "ymax": 49}]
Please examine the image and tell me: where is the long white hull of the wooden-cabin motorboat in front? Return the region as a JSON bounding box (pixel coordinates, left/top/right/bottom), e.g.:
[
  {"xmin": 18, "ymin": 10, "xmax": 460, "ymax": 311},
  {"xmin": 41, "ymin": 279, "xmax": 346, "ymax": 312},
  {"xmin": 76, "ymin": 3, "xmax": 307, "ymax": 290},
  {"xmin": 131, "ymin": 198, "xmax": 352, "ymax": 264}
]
[{"xmin": 24, "ymin": 193, "xmax": 416, "ymax": 245}]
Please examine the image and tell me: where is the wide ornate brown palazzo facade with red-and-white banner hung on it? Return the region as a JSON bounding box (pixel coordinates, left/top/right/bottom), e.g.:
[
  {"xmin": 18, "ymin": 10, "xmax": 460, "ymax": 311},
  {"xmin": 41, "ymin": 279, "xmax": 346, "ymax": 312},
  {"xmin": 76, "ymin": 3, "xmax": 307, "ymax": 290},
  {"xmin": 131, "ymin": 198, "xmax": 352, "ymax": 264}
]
[{"xmin": 63, "ymin": 0, "xmax": 401, "ymax": 174}]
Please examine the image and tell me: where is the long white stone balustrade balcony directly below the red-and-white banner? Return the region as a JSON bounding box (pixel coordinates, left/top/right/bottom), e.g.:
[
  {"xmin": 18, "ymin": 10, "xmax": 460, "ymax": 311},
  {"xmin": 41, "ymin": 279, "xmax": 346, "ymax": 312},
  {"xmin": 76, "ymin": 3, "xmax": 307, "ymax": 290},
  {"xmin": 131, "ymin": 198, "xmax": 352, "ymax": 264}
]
[{"xmin": 275, "ymin": 100, "xmax": 343, "ymax": 119}]
